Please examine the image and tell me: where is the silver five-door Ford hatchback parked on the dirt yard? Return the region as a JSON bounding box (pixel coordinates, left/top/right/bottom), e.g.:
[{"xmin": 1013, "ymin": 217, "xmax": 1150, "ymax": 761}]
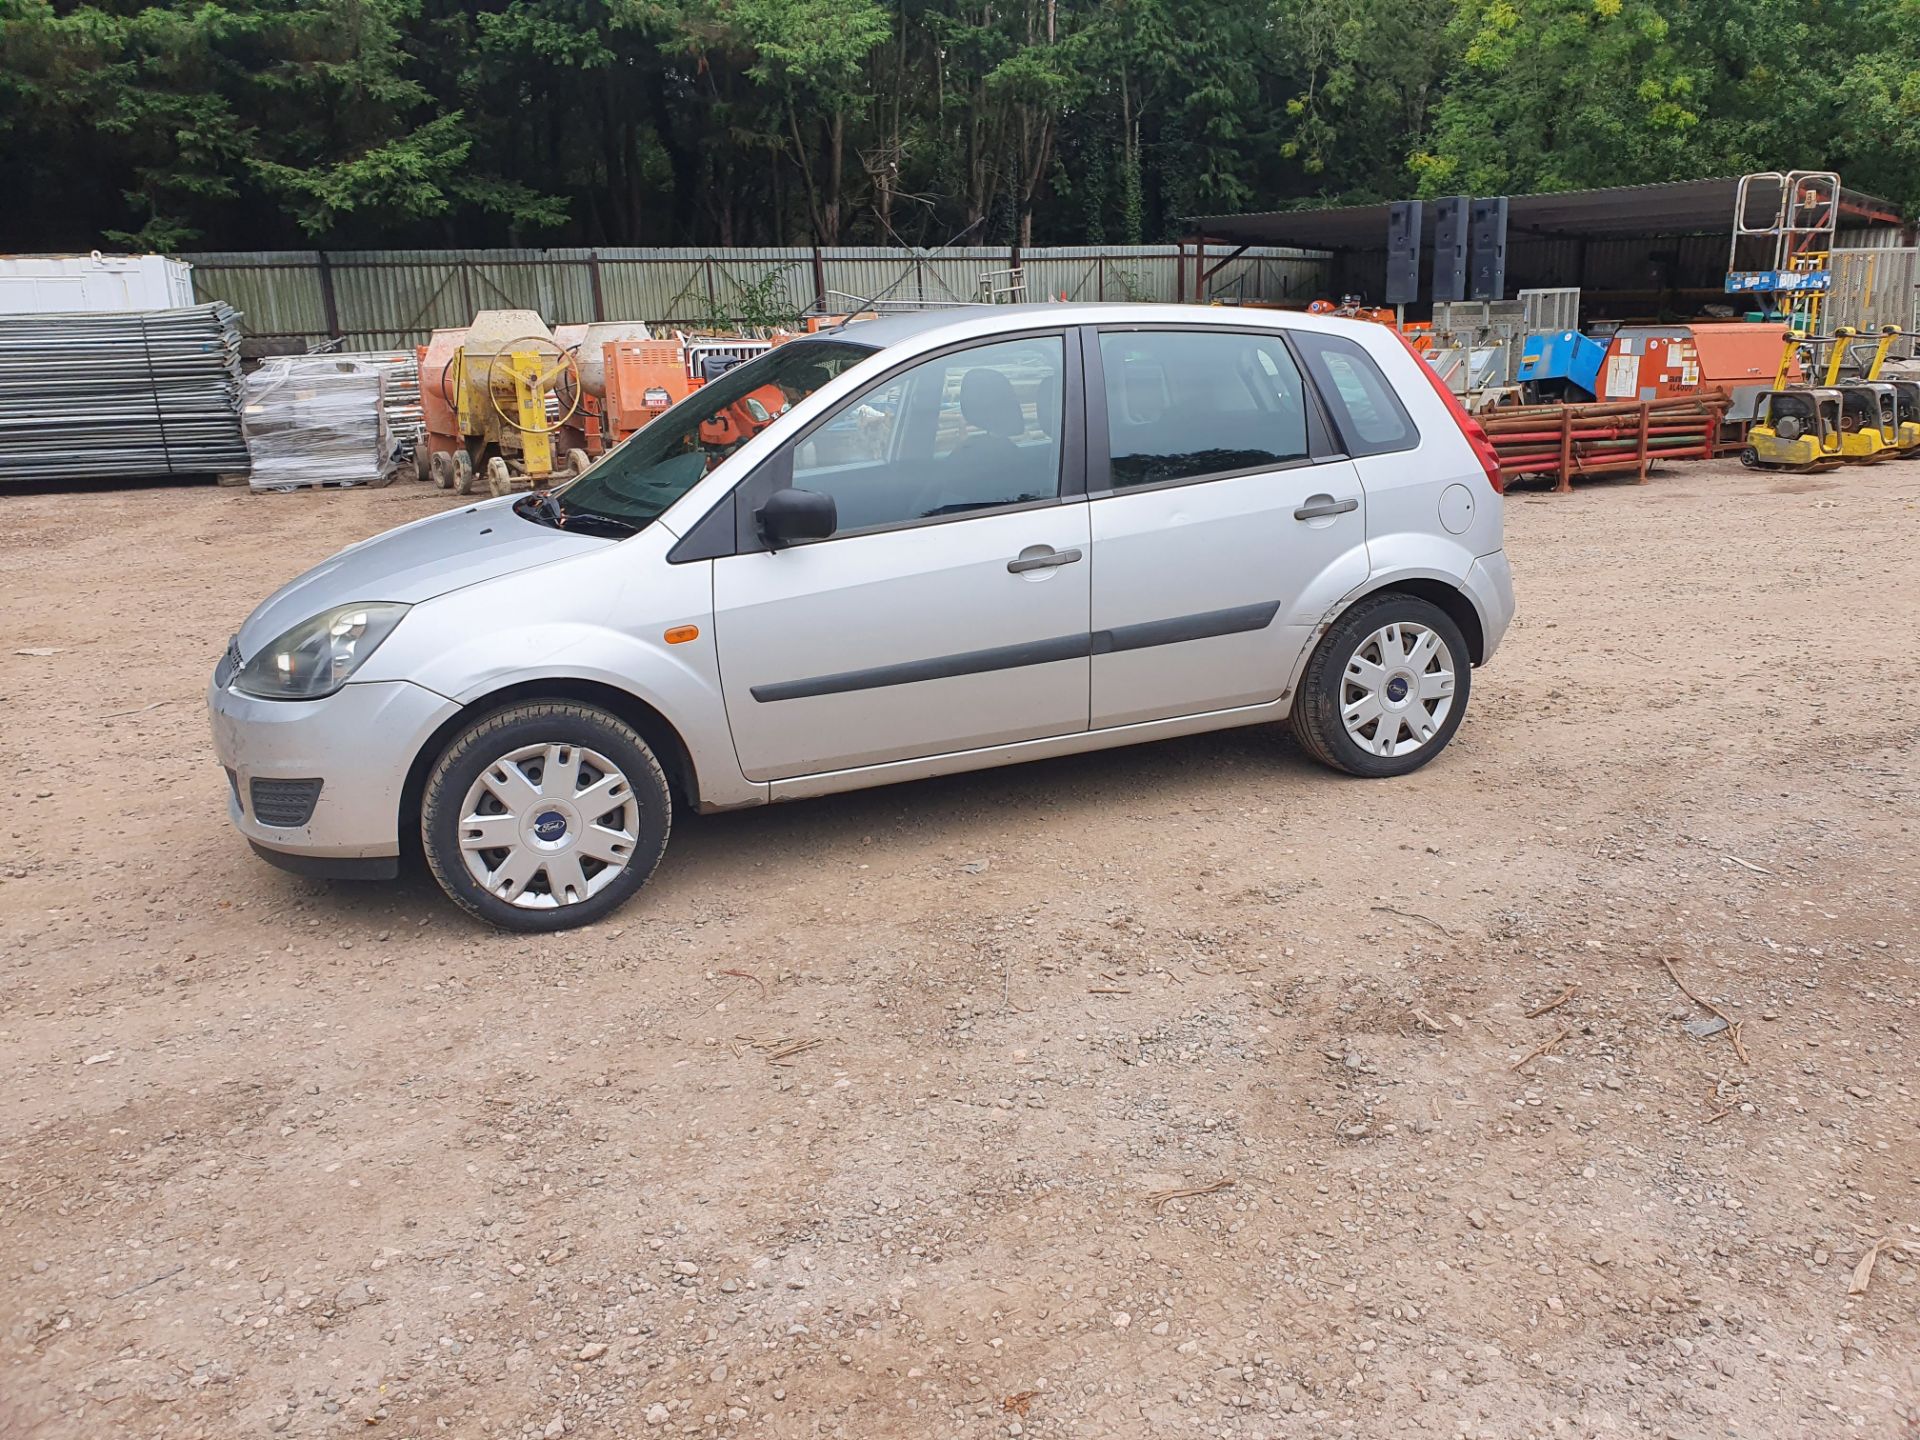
[{"xmin": 209, "ymin": 305, "xmax": 1513, "ymax": 929}]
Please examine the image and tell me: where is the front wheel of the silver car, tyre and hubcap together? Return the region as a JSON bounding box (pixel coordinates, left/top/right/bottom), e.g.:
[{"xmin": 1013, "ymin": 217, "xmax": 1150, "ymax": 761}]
[{"xmin": 420, "ymin": 701, "xmax": 674, "ymax": 931}]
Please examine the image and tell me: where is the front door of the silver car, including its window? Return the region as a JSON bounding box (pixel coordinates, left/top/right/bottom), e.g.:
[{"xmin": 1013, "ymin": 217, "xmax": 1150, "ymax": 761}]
[{"xmin": 714, "ymin": 334, "xmax": 1092, "ymax": 781}]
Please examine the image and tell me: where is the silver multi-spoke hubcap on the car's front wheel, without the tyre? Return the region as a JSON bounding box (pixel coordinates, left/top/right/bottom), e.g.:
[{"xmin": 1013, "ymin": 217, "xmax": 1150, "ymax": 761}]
[{"xmin": 459, "ymin": 745, "xmax": 639, "ymax": 910}]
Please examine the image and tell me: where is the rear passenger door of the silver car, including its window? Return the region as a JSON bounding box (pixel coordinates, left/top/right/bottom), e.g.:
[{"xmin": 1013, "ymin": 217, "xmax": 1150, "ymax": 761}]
[{"xmin": 1087, "ymin": 326, "xmax": 1367, "ymax": 730}]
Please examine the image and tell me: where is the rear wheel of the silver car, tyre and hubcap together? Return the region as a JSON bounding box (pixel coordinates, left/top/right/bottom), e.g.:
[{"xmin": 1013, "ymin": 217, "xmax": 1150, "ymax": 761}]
[{"xmin": 1290, "ymin": 589, "xmax": 1473, "ymax": 780}]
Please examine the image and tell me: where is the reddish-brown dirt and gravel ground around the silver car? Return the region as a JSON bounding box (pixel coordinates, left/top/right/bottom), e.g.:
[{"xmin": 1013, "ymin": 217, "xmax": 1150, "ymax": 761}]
[{"xmin": 0, "ymin": 463, "xmax": 1920, "ymax": 1440}]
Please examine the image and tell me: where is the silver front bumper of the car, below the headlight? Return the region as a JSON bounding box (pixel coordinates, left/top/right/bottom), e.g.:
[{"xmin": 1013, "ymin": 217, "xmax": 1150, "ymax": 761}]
[{"xmin": 207, "ymin": 678, "xmax": 459, "ymax": 876}]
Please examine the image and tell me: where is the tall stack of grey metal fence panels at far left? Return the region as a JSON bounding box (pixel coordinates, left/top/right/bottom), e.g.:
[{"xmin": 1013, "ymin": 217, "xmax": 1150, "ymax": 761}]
[{"xmin": 0, "ymin": 303, "xmax": 248, "ymax": 482}]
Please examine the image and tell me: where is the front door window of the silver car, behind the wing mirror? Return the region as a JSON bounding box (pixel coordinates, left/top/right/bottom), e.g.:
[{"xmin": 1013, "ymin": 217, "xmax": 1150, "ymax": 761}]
[{"xmin": 793, "ymin": 336, "xmax": 1066, "ymax": 536}]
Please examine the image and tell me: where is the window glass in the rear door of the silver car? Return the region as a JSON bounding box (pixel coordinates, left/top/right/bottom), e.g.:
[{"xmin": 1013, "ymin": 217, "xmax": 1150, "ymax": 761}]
[{"xmin": 1094, "ymin": 330, "xmax": 1308, "ymax": 490}]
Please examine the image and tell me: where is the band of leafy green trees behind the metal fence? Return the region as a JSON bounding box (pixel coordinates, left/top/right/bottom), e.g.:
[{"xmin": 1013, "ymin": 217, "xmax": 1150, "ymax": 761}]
[{"xmin": 0, "ymin": 0, "xmax": 1920, "ymax": 251}]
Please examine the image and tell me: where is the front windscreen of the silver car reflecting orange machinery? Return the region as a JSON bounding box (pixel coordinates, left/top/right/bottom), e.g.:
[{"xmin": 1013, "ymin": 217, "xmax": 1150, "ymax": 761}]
[{"xmin": 559, "ymin": 340, "xmax": 876, "ymax": 530}]
